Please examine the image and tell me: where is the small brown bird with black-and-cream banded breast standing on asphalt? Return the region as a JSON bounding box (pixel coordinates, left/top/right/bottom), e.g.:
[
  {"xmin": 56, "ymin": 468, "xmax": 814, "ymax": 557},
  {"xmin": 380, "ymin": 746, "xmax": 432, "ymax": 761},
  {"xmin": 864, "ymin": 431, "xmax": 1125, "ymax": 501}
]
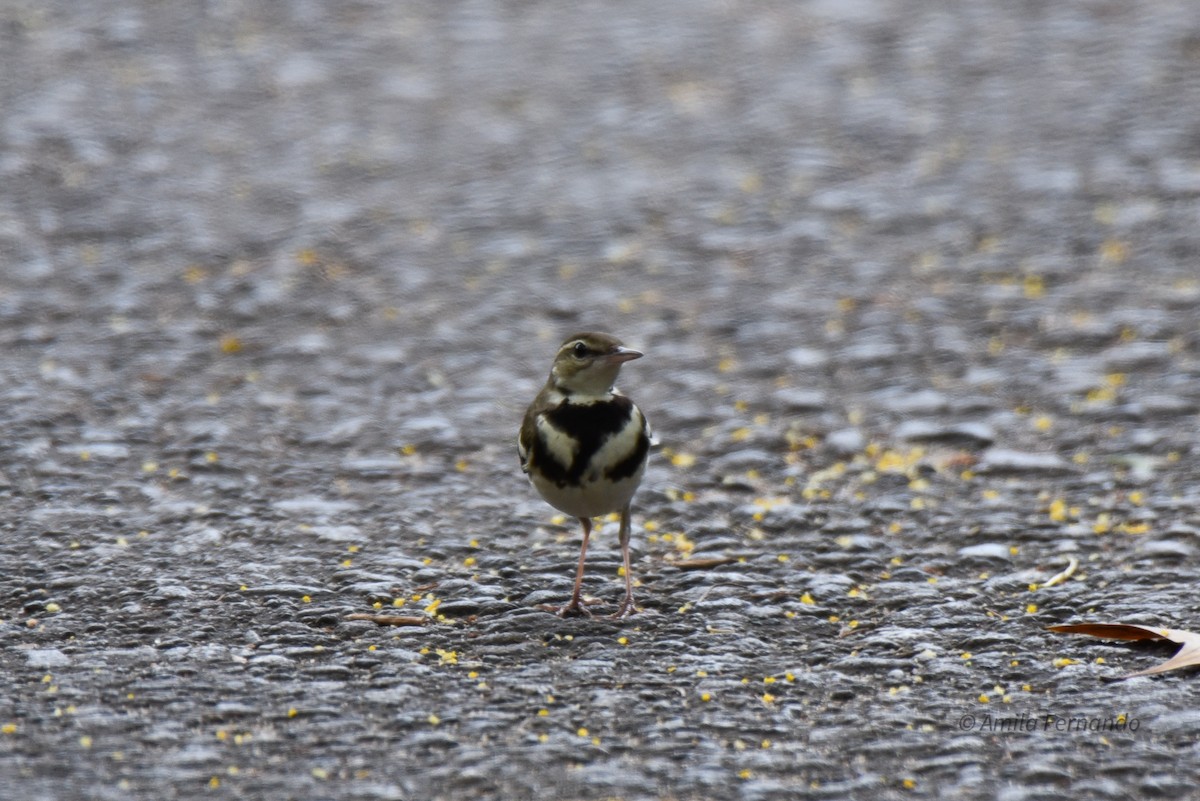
[{"xmin": 517, "ymin": 332, "xmax": 652, "ymax": 618}]
